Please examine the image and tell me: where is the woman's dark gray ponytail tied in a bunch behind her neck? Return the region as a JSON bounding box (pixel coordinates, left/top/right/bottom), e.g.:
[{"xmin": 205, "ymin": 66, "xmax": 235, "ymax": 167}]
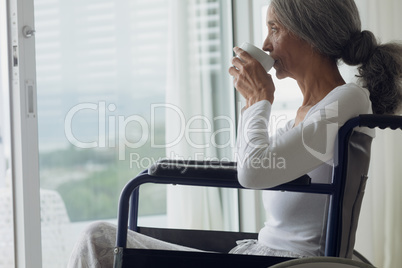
[{"xmin": 341, "ymin": 31, "xmax": 402, "ymax": 114}]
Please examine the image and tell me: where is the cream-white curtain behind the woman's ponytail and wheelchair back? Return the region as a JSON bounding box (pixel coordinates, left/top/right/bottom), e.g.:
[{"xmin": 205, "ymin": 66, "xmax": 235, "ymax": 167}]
[{"xmin": 356, "ymin": 0, "xmax": 402, "ymax": 268}]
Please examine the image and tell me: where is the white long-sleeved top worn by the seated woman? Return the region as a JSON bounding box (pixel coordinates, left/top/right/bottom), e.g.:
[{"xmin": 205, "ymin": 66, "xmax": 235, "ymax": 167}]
[{"xmin": 236, "ymin": 84, "xmax": 374, "ymax": 256}]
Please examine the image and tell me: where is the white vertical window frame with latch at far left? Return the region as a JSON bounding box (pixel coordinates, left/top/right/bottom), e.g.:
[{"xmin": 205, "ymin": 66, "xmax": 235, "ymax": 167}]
[{"xmin": 6, "ymin": 0, "xmax": 42, "ymax": 267}]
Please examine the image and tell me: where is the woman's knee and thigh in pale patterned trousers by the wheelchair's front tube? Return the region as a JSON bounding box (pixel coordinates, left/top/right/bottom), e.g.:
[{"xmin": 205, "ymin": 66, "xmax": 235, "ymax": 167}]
[{"xmin": 67, "ymin": 222, "xmax": 203, "ymax": 268}]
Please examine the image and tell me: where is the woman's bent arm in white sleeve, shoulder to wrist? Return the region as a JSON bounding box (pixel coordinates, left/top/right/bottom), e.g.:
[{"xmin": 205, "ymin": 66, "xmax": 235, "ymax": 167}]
[{"xmin": 237, "ymin": 85, "xmax": 371, "ymax": 189}]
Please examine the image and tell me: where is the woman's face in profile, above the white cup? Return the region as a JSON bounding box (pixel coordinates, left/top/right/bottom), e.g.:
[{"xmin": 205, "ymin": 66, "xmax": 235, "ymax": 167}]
[{"xmin": 263, "ymin": 6, "xmax": 312, "ymax": 79}]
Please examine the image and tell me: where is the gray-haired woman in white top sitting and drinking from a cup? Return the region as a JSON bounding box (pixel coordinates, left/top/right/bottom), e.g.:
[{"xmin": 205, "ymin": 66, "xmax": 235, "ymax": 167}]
[{"xmin": 69, "ymin": 0, "xmax": 402, "ymax": 267}]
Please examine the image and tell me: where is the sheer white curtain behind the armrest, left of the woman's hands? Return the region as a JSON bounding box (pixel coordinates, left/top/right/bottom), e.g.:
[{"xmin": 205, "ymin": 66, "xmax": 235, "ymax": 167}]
[{"xmin": 165, "ymin": 0, "xmax": 235, "ymax": 229}]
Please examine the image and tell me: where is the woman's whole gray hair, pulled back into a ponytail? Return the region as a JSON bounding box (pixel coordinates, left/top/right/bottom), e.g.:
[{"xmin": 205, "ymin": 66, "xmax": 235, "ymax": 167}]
[{"xmin": 271, "ymin": 0, "xmax": 402, "ymax": 114}]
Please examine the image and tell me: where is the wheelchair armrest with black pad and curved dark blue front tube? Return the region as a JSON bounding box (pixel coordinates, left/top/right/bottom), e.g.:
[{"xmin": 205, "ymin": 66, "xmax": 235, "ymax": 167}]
[{"xmin": 116, "ymin": 160, "xmax": 318, "ymax": 247}]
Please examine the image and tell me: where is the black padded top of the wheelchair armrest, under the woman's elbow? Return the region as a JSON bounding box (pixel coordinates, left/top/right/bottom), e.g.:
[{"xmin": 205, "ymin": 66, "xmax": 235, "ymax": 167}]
[{"xmin": 148, "ymin": 159, "xmax": 311, "ymax": 188}]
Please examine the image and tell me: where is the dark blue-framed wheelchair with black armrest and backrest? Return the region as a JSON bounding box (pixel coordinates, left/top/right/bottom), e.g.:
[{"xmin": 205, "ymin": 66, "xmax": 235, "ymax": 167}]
[{"xmin": 114, "ymin": 115, "xmax": 402, "ymax": 268}]
